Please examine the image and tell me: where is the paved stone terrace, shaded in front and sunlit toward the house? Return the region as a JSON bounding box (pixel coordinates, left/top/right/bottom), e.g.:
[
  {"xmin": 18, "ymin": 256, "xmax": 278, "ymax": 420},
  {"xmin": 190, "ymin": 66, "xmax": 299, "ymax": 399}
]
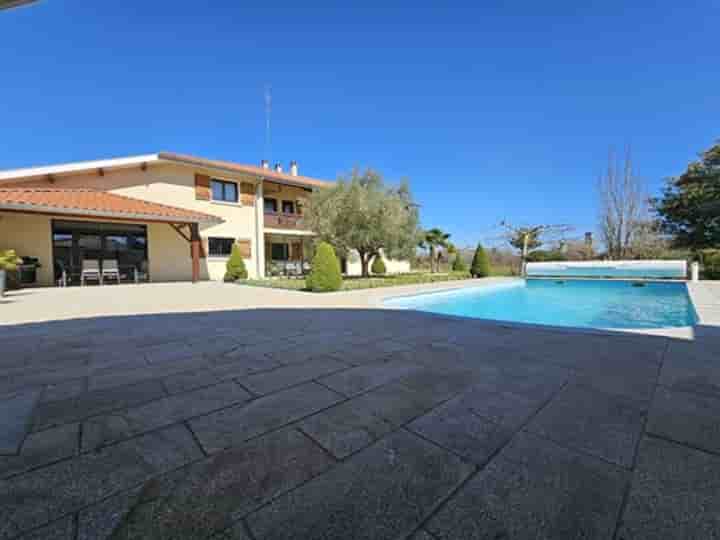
[{"xmin": 0, "ymin": 283, "xmax": 720, "ymax": 540}]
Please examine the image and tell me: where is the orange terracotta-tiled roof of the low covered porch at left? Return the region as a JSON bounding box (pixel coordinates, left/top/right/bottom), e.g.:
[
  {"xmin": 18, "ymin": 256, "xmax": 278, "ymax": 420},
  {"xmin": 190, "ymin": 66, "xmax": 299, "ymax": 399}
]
[{"xmin": 0, "ymin": 188, "xmax": 223, "ymax": 224}]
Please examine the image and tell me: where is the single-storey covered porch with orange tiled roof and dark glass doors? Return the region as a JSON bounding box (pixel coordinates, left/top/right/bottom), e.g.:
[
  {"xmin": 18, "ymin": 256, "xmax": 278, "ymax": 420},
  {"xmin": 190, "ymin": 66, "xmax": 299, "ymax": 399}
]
[{"xmin": 0, "ymin": 188, "xmax": 222, "ymax": 286}]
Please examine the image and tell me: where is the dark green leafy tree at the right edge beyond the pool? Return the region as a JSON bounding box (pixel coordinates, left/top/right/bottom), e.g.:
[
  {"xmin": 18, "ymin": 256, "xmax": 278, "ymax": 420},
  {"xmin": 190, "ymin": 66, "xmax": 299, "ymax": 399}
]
[{"xmin": 652, "ymin": 143, "xmax": 720, "ymax": 250}]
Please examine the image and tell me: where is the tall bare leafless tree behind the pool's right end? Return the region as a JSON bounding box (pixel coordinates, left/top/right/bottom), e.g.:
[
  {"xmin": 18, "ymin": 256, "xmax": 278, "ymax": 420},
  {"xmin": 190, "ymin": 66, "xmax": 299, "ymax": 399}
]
[{"xmin": 598, "ymin": 148, "xmax": 649, "ymax": 259}]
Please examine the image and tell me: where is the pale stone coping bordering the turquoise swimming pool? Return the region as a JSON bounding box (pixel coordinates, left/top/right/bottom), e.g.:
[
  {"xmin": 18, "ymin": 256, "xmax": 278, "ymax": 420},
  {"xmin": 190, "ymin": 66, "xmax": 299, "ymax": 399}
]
[{"xmin": 373, "ymin": 277, "xmax": 708, "ymax": 339}]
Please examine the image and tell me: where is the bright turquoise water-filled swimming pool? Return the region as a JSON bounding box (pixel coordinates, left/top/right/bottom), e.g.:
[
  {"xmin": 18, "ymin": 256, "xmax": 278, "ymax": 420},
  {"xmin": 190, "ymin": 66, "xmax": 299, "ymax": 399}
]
[{"xmin": 385, "ymin": 279, "xmax": 697, "ymax": 329}]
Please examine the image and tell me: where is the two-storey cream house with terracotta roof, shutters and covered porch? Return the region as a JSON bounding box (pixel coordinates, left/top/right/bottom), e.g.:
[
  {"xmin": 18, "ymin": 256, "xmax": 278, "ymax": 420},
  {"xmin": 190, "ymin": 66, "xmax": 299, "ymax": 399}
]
[{"xmin": 0, "ymin": 152, "xmax": 409, "ymax": 285}]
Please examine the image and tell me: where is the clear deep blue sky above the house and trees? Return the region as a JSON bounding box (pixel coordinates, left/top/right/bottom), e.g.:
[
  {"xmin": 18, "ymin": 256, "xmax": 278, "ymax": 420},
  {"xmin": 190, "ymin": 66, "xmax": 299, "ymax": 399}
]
[{"xmin": 0, "ymin": 0, "xmax": 720, "ymax": 244}]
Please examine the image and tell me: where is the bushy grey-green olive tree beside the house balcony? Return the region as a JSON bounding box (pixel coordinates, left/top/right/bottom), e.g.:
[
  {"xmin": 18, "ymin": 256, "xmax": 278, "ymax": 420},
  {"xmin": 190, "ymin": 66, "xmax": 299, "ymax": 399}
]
[{"xmin": 307, "ymin": 169, "xmax": 419, "ymax": 277}]
